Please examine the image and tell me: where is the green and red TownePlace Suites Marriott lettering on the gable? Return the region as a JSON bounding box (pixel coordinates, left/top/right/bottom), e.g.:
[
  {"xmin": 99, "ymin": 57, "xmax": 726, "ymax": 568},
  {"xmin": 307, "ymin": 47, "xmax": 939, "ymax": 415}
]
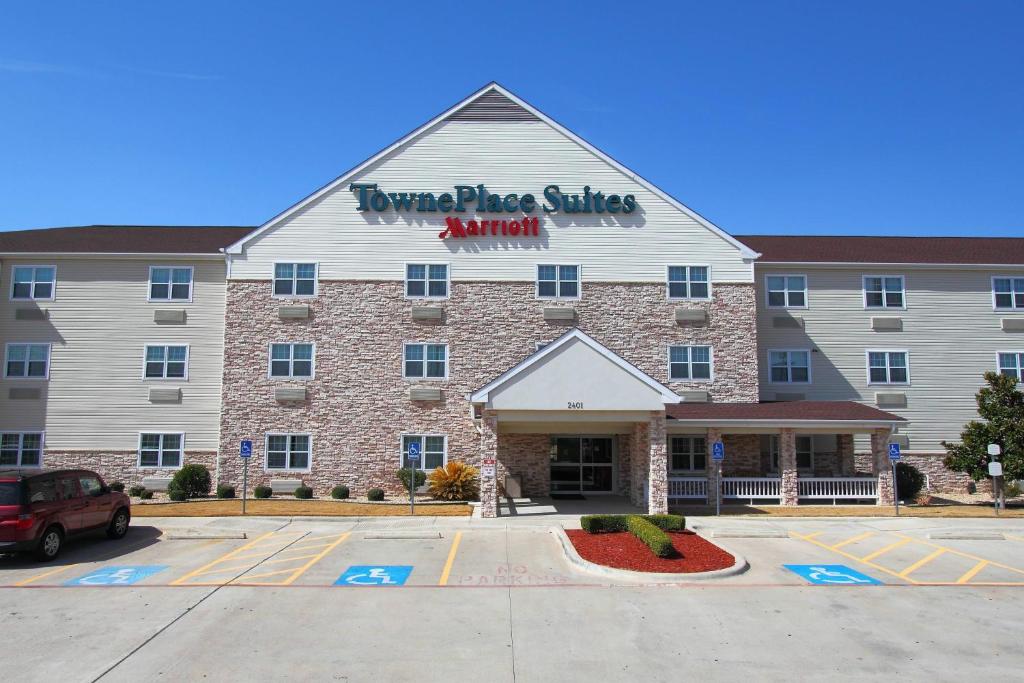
[{"xmin": 348, "ymin": 182, "xmax": 637, "ymax": 240}]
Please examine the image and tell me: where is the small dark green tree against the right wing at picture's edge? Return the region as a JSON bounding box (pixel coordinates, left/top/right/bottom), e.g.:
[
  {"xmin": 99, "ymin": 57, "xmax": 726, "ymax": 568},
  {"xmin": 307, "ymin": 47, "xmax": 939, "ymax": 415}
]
[{"xmin": 942, "ymin": 373, "xmax": 1024, "ymax": 481}]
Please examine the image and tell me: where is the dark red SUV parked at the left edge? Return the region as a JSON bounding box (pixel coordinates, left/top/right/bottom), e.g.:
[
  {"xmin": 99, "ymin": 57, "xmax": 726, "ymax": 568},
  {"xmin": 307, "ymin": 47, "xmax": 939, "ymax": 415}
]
[{"xmin": 0, "ymin": 470, "xmax": 131, "ymax": 562}]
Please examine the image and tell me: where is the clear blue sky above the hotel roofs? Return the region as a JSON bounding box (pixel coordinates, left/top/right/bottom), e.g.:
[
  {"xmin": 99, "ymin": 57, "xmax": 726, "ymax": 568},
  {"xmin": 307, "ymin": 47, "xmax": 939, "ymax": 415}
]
[{"xmin": 0, "ymin": 0, "xmax": 1024, "ymax": 236}]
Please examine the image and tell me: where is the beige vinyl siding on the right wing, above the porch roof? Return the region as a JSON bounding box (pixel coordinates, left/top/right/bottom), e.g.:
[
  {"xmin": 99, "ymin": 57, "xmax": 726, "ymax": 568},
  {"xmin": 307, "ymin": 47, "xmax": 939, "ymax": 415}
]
[{"xmin": 757, "ymin": 265, "xmax": 1024, "ymax": 452}]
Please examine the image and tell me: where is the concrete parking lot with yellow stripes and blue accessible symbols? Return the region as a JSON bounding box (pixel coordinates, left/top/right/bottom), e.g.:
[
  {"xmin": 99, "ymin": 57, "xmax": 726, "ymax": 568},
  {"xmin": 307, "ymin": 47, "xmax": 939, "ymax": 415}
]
[{"xmin": 6, "ymin": 518, "xmax": 1024, "ymax": 681}]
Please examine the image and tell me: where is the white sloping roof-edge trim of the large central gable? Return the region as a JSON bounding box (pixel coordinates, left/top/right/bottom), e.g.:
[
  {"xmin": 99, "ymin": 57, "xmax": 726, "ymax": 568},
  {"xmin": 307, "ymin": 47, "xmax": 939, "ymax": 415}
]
[{"xmin": 226, "ymin": 82, "xmax": 758, "ymax": 259}]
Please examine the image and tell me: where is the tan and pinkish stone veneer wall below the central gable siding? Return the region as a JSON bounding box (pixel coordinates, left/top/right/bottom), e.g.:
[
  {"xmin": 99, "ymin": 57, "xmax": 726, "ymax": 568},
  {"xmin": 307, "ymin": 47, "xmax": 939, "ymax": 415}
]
[{"xmin": 220, "ymin": 281, "xmax": 758, "ymax": 496}]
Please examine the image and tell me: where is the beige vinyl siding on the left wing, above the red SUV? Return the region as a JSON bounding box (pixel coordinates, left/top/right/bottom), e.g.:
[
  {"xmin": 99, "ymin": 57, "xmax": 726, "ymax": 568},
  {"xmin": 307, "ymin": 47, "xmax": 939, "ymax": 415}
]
[{"xmin": 0, "ymin": 257, "xmax": 225, "ymax": 451}]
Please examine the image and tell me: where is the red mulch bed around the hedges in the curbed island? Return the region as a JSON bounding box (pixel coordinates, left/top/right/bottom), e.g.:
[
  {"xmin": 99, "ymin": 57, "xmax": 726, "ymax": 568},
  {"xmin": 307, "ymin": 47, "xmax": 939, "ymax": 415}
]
[{"xmin": 565, "ymin": 529, "xmax": 736, "ymax": 573}]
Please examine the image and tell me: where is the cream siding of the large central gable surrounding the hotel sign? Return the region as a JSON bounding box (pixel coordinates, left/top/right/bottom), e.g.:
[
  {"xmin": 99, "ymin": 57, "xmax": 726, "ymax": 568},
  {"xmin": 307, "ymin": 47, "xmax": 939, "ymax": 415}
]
[{"xmin": 231, "ymin": 122, "xmax": 752, "ymax": 282}]
